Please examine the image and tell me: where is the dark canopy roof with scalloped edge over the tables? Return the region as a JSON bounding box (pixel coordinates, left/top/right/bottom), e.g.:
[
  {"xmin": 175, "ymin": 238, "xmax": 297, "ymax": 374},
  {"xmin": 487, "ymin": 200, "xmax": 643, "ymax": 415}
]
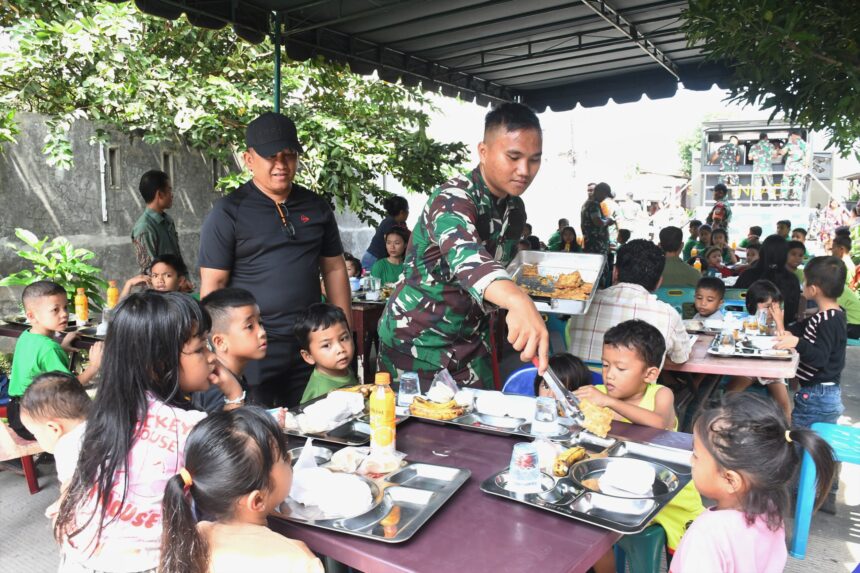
[{"xmin": 111, "ymin": 0, "xmax": 730, "ymax": 111}]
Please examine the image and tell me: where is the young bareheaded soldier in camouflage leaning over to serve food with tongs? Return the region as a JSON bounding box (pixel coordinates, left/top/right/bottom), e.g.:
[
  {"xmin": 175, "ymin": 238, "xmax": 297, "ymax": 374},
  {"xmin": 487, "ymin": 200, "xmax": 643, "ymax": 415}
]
[{"xmin": 379, "ymin": 104, "xmax": 549, "ymax": 388}]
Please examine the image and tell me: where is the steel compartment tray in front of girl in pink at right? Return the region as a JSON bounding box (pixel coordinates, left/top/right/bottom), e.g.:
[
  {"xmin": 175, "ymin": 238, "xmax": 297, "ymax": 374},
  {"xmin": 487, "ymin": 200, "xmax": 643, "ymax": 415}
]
[{"xmin": 481, "ymin": 441, "xmax": 692, "ymax": 534}]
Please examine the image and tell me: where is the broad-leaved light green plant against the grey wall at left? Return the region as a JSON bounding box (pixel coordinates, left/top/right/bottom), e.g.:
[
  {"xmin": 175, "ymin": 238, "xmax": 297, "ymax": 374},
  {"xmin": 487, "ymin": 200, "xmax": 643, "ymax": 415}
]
[{"xmin": 0, "ymin": 229, "xmax": 108, "ymax": 310}]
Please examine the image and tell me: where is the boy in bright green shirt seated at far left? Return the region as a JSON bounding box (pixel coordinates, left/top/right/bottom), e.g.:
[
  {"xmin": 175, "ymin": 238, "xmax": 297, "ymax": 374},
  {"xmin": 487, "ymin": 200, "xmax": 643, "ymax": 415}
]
[{"xmin": 7, "ymin": 281, "xmax": 103, "ymax": 440}]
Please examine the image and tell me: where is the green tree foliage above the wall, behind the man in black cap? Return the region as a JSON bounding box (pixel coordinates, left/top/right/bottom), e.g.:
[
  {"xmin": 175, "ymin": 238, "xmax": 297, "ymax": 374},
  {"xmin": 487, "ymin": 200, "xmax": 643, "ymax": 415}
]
[{"xmin": 0, "ymin": 0, "xmax": 466, "ymax": 222}]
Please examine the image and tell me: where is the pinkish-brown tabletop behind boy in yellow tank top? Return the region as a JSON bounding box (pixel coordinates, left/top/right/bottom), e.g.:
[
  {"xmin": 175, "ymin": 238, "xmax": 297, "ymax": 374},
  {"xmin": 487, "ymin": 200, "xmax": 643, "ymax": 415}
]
[{"xmin": 663, "ymin": 334, "xmax": 800, "ymax": 379}]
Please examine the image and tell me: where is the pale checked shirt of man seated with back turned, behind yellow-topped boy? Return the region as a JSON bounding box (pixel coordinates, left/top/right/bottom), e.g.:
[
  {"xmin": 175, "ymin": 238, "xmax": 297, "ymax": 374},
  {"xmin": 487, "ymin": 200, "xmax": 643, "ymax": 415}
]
[{"xmin": 568, "ymin": 283, "xmax": 690, "ymax": 363}]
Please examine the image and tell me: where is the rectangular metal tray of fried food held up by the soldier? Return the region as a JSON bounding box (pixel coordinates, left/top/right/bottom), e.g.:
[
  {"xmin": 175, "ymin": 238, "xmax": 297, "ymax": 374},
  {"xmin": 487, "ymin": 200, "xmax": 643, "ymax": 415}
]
[{"xmin": 507, "ymin": 251, "xmax": 606, "ymax": 314}]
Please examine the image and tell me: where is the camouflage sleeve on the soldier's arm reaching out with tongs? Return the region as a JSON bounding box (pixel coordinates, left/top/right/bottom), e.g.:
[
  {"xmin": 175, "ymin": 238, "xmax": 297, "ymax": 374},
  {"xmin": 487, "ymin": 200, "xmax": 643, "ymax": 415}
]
[{"xmin": 427, "ymin": 187, "xmax": 510, "ymax": 304}]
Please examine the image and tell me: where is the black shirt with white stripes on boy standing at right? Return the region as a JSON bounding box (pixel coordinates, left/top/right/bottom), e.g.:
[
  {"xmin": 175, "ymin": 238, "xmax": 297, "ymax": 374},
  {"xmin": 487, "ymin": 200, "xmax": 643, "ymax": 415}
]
[{"xmin": 788, "ymin": 309, "xmax": 848, "ymax": 386}]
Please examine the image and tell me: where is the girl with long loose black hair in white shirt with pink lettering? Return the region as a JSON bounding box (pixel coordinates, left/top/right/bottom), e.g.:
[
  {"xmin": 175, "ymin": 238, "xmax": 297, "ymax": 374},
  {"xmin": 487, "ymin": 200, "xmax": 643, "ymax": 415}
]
[{"xmin": 54, "ymin": 291, "xmax": 217, "ymax": 573}]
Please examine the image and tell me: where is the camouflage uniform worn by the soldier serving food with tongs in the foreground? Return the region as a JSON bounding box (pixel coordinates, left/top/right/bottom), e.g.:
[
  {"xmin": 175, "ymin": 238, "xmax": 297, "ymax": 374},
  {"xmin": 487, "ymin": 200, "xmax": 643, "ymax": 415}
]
[{"xmin": 379, "ymin": 168, "xmax": 521, "ymax": 388}]
